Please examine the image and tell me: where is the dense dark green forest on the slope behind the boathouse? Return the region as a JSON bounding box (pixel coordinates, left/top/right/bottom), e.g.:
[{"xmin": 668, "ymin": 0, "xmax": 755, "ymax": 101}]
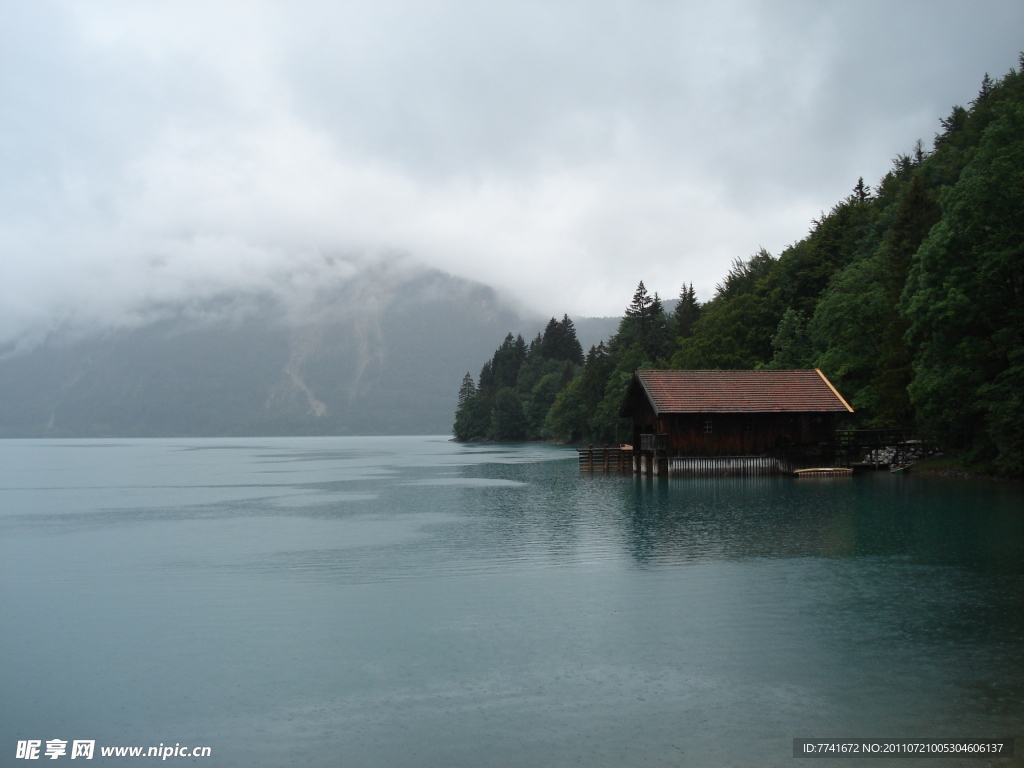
[{"xmin": 454, "ymin": 60, "xmax": 1024, "ymax": 476}]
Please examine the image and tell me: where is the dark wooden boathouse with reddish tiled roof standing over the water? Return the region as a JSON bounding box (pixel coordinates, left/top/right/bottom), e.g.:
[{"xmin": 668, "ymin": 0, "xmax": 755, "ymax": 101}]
[{"xmin": 620, "ymin": 369, "xmax": 853, "ymax": 475}]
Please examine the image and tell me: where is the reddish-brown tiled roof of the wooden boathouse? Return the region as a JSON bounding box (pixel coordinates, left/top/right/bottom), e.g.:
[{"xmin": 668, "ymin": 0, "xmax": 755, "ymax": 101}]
[{"xmin": 636, "ymin": 369, "xmax": 853, "ymax": 414}]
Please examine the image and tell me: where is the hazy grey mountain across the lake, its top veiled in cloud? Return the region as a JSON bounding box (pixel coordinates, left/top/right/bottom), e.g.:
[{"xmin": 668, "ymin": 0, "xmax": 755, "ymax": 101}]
[{"xmin": 0, "ymin": 259, "xmax": 617, "ymax": 437}]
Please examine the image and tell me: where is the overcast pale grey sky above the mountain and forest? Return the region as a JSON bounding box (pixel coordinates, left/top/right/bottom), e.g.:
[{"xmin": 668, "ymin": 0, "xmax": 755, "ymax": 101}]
[{"xmin": 0, "ymin": 0, "xmax": 1024, "ymax": 338}]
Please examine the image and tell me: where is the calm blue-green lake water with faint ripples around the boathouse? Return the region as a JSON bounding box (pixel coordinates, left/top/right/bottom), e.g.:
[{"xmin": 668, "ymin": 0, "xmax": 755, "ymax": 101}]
[{"xmin": 0, "ymin": 437, "xmax": 1024, "ymax": 768}]
